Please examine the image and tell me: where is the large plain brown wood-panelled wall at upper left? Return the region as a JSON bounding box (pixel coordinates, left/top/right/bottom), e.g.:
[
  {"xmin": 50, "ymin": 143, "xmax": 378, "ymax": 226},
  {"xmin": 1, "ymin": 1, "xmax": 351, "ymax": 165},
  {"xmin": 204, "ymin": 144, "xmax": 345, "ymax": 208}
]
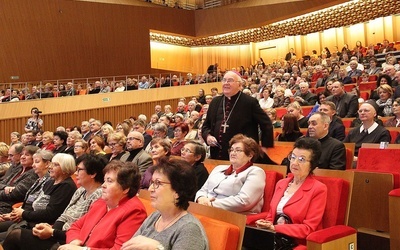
[{"xmin": 0, "ymin": 0, "xmax": 194, "ymax": 82}]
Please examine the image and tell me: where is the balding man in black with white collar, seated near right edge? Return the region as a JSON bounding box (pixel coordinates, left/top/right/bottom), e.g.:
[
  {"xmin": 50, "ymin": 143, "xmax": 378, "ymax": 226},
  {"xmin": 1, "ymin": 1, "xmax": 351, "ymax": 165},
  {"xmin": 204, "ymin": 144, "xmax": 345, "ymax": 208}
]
[{"xmin": 343, "ymin": 100, "xmax": 391, "ymax": 161}]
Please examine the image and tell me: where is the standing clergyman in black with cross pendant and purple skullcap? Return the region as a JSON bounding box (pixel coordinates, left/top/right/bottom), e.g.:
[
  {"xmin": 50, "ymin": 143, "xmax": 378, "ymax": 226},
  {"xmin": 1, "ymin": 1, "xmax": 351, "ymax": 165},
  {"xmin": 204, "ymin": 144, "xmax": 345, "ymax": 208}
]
[{"xmin": 202, "ymin": 71, "xmax": 274, "ymax": 161}]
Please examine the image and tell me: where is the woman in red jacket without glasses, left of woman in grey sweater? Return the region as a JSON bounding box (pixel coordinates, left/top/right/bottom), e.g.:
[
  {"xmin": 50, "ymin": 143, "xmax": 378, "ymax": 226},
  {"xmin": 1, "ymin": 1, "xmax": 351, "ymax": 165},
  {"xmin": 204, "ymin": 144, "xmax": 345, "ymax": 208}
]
[{"xmin": 58, "ymin": 161, "xmax": 147, "ymax": 250}]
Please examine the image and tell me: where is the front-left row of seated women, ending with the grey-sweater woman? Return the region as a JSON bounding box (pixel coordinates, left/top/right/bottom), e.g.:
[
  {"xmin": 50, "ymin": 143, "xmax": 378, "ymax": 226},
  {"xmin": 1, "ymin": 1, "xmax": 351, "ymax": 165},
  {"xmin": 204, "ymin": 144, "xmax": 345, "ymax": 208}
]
[{"xmin": 0, "ymin": 143, "xmax": 208, "ymax": 249}]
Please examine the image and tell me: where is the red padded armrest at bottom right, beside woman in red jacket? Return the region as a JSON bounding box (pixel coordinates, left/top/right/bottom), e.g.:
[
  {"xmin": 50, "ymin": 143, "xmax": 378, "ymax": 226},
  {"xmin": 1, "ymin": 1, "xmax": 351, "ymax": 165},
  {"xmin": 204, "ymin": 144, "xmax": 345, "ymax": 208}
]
[{"xmin": 307, "ymin": 225, "xmax": 357, "ymax": 244}]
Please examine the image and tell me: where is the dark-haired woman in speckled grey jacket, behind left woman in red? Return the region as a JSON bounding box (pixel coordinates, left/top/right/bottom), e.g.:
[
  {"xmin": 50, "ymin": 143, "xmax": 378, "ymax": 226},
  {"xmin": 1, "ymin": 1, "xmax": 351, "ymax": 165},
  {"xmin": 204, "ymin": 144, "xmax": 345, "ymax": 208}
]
[{"xmin": 3, "ymin": 153, "xmax": 107, "ymax": 250}]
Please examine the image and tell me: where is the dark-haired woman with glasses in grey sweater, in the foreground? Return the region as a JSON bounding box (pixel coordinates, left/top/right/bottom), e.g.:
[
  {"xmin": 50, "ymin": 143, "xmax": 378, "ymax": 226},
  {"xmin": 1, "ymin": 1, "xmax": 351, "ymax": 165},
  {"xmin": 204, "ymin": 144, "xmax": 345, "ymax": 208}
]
[{"xmin": 121, "ymin": 158, "xmax": 209, "ymax": 250}]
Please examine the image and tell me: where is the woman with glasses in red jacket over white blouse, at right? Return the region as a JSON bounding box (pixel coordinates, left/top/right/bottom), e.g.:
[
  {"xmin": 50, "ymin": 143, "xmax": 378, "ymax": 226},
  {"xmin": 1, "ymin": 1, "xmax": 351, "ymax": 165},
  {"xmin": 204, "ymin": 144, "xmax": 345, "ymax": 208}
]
[{"xmin": 256, "ymin": 137, "xmax": 327, "ymax": 247}]
